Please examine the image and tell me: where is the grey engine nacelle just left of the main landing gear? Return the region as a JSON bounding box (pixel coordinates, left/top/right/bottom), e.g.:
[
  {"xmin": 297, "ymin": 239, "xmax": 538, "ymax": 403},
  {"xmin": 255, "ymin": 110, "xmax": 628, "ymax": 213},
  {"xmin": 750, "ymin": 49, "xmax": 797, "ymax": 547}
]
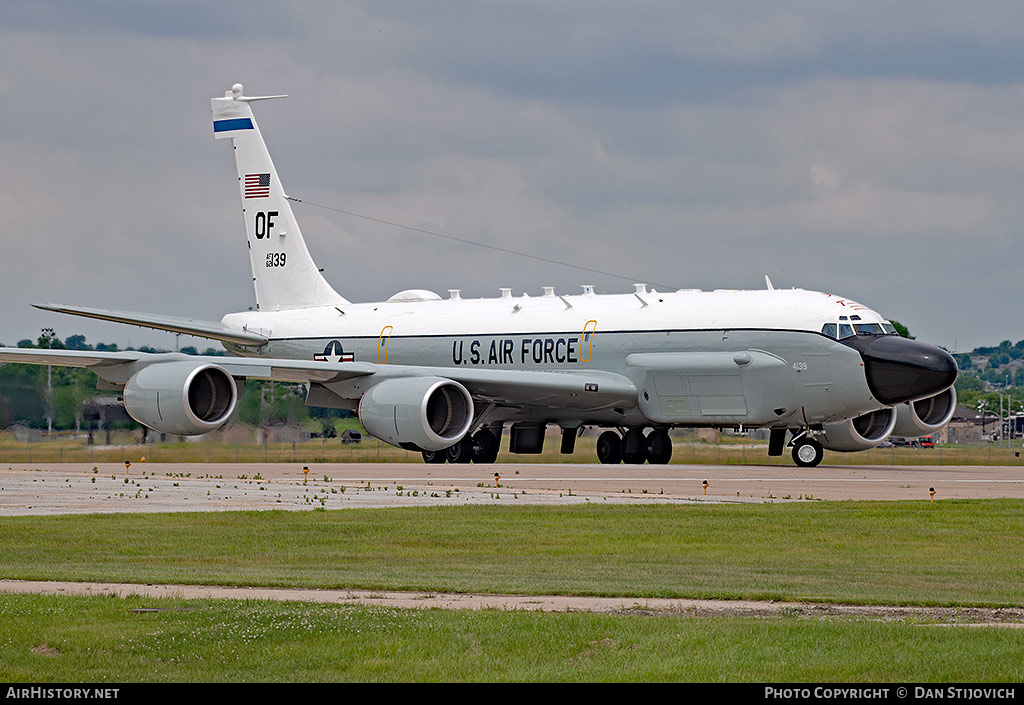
[{"xmin": 359, "ymin": 377, "xmax": 473, "ymax": 451}]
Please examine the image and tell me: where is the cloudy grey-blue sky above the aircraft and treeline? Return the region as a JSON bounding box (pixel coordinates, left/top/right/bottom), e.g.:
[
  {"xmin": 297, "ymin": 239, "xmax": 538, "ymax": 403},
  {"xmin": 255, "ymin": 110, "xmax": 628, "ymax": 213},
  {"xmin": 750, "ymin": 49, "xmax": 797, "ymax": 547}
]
[{"xmin": 0, "ymin": 0, "xmax": 1024, "ymax": 350}]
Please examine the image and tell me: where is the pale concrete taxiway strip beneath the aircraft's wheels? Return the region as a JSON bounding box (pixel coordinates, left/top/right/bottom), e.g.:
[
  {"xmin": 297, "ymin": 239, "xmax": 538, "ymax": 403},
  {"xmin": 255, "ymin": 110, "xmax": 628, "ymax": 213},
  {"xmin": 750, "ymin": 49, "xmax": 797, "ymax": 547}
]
[{"xmin": 0, "ymin": 463, "xmax": 1024, "ymax": 516}]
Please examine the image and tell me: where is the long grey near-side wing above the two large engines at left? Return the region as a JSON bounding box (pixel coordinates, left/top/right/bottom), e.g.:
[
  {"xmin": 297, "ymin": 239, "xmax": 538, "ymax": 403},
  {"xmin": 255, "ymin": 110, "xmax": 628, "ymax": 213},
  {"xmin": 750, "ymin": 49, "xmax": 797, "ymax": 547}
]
[{"xmin": 0, "ymin": 347, "xmax": 637, "ymax": 410}]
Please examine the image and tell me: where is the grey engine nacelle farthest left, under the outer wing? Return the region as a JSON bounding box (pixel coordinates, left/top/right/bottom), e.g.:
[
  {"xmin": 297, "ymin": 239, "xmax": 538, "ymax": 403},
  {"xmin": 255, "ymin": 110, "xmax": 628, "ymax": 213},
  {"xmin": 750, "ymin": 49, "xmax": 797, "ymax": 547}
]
[{"xmin": 124, "ymin": 360, "xmax": 239, "ymax": 436}]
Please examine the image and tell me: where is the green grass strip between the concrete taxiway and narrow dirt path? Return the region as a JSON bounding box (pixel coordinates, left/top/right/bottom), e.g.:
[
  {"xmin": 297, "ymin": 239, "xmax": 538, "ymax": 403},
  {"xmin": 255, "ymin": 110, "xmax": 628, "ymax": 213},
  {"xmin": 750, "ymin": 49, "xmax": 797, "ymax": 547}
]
[{"xmin": 0, "ymin": 500, "xmax": 1024, "ymax": 607}]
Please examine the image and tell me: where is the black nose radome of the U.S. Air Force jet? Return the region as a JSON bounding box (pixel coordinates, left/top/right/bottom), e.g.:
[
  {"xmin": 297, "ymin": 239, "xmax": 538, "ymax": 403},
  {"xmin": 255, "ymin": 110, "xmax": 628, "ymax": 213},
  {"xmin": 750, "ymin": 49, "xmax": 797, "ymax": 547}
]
[{"xmin": 843, "ymin": 335, "xmax": 956, "ymax": 405}]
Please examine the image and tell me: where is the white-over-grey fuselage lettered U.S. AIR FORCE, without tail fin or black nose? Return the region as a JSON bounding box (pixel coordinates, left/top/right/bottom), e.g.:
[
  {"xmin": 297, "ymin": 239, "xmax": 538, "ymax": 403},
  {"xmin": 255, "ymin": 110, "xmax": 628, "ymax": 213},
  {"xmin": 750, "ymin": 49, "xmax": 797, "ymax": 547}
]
[{"xmin": 223, "ymin": 288, "xmax": 888, "ymax": 426}]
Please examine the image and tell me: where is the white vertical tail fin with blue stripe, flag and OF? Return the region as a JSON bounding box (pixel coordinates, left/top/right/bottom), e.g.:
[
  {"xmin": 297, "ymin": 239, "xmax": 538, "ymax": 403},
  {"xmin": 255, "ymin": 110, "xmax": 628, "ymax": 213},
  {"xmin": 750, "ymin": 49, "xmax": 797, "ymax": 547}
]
[{"xmin": 210, "ymin": 83, "xmax": 348, "ymax": 310}]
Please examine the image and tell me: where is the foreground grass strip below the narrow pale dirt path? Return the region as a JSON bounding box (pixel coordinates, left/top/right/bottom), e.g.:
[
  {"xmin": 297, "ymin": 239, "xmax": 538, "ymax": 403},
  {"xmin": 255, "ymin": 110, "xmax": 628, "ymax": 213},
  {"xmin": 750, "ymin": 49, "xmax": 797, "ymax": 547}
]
[{"xmin": 0, "ymin": 595, "xmax": 1024, "ymax": 682}]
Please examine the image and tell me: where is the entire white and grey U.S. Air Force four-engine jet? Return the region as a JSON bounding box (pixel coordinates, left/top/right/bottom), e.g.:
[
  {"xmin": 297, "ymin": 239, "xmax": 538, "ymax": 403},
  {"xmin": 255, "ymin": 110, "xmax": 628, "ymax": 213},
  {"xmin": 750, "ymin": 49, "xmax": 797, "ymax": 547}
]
[{"xmin": 0, "ymin": 84, "xmax": 956, "ymax": 466}]
